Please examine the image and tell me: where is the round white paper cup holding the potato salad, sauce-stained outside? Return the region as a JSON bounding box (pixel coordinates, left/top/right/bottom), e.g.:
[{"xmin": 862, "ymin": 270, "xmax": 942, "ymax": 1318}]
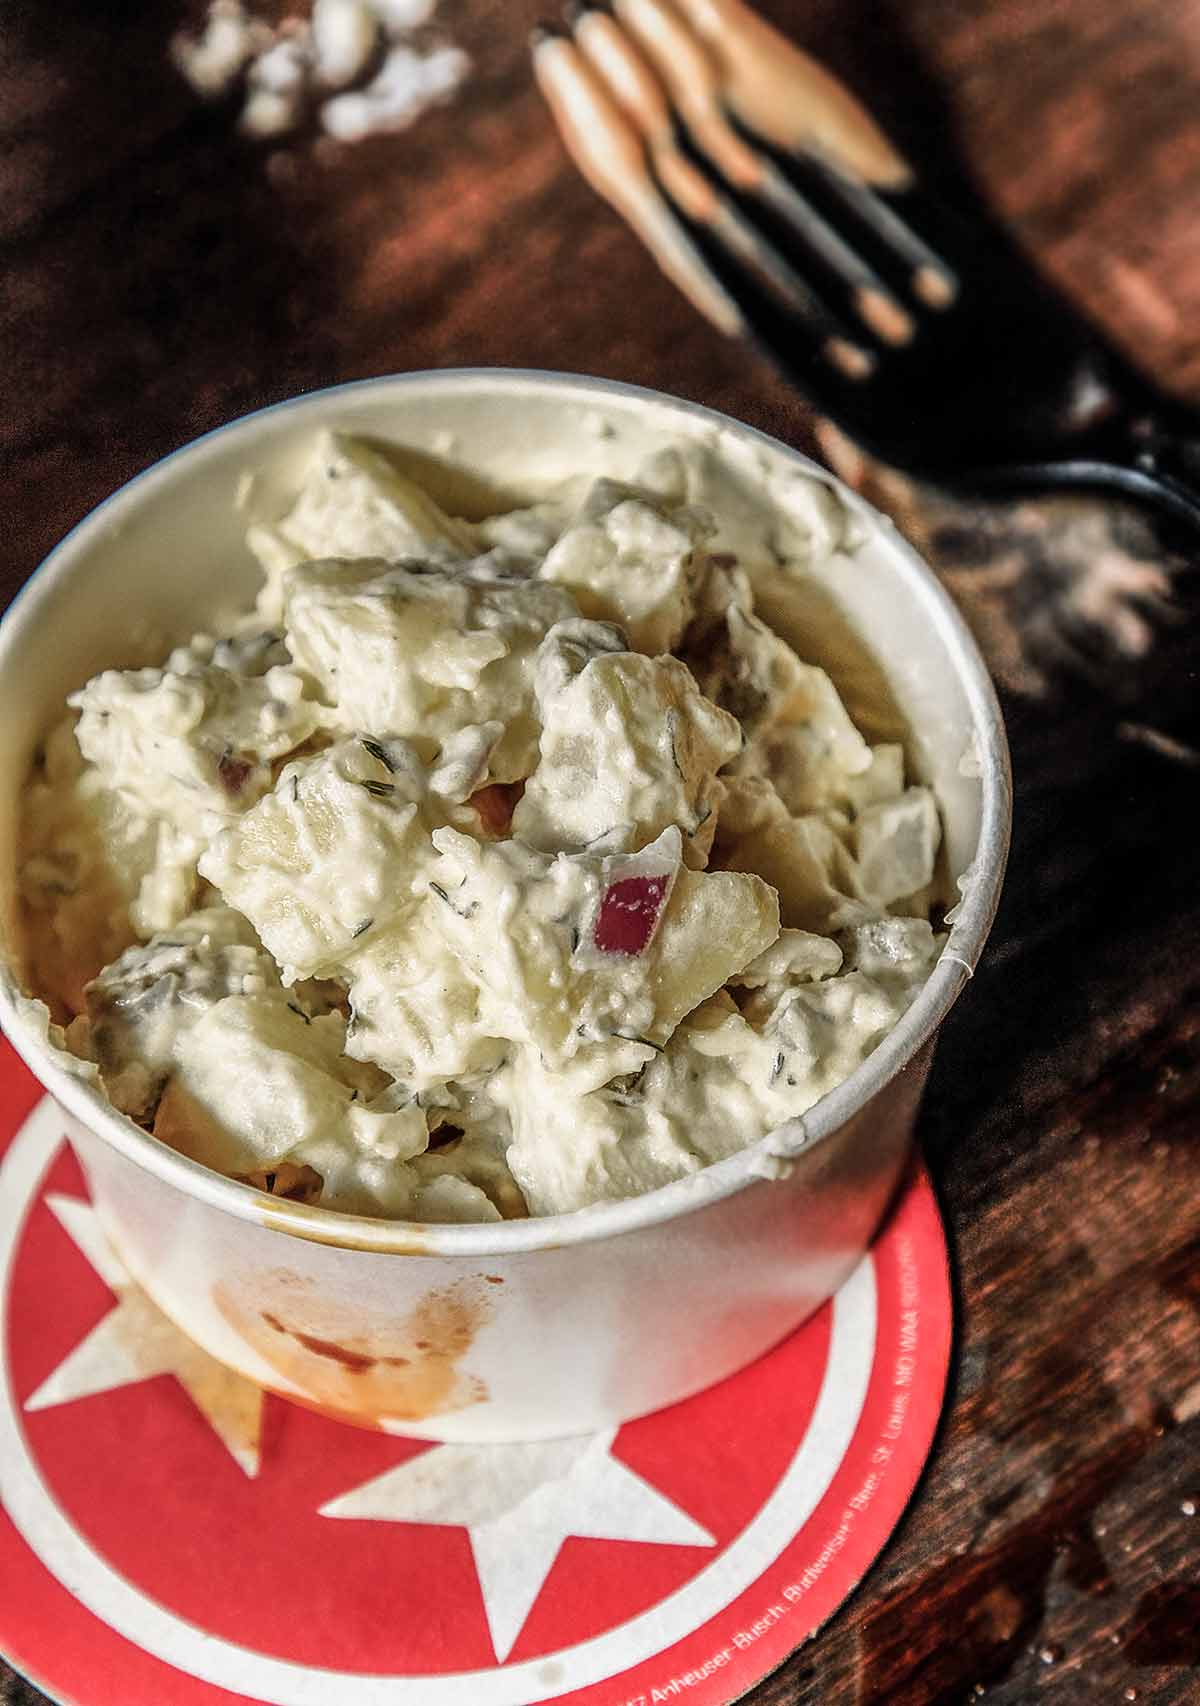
[{"xmin": 0, "ymin": 370, "xmax": 1011, "ymax": 1440}]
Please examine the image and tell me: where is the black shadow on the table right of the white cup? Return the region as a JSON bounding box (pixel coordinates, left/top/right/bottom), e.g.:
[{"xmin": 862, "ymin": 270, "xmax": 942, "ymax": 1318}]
[{"xmin": 922, "ymin": 504, "xmax": 1200, "ymax": 1192}]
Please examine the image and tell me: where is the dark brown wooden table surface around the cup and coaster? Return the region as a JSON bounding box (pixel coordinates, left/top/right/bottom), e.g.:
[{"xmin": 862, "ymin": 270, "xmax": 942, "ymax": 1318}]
[{"xmin": 0, "ymin": 0, "xmax": 1200, "ymax": 1706}]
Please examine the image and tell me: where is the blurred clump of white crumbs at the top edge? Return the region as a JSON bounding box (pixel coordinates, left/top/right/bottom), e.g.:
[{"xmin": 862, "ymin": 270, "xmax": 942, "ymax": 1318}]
[{"xmin": 171, "ymin": 0, "xmax": 469, "ymax": 142}]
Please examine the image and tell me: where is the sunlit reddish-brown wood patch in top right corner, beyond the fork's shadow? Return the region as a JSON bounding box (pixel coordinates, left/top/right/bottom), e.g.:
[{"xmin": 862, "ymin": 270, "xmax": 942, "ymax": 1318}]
[{"xmin": 893, "ymin": 0, "xmax": 1200, "ymax": 403}]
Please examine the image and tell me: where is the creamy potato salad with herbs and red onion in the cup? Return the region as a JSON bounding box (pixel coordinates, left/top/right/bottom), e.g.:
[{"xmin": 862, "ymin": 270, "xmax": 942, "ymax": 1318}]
[{"xmin": 14, "ymin": 433, "xmax": 942, "ymax": 1221}]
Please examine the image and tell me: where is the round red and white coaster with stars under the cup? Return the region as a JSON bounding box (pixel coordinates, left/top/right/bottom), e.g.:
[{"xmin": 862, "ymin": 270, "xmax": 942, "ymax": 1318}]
[{"xmin": 0, "ymin": 1044, "xmax": 951, "ymax": 1706}]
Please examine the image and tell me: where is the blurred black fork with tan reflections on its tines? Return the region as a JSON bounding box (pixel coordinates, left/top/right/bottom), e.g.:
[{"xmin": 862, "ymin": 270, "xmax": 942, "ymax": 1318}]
[{"xmin": 533, "ymin": 0, "xmax": 1200, "ymax": 531}]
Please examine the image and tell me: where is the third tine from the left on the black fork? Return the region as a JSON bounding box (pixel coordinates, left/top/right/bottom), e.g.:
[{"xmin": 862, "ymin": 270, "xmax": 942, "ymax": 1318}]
[{"xmin": 611, "ymin": 0, "xmax": 917, "ymax": 345}]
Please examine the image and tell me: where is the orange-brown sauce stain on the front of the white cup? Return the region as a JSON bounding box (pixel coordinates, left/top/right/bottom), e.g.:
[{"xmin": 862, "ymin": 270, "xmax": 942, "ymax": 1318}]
[{"xmin": 213, "ymin": 1271, "xmax": 492, "ymax": 1426}]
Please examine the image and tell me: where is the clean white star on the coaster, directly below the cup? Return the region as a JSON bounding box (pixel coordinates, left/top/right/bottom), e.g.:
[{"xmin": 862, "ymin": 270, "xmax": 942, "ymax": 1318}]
[{"xmin": 319, "ymin": 1428, "xmax": 717, "ymax": 1663}]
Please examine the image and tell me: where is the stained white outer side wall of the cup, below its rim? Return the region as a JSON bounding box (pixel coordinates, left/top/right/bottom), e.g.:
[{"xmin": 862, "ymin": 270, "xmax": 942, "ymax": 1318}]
[{"xmin": 63, "ymin": 1044, "xmax": 932, "ymax": 1440}]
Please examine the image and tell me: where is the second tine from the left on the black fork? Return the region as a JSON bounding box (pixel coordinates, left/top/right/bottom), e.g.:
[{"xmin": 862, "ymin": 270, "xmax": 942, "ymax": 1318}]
[{"xmin": 572, "ymin": 5, "xmax": 874, "ymax": 377}]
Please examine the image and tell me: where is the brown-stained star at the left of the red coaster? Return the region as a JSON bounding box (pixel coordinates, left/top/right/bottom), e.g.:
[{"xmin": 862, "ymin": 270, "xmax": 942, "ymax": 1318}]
[{"xmin": 26, "ymin": 1194, "xmax": 263, "ymax": 1476}]
